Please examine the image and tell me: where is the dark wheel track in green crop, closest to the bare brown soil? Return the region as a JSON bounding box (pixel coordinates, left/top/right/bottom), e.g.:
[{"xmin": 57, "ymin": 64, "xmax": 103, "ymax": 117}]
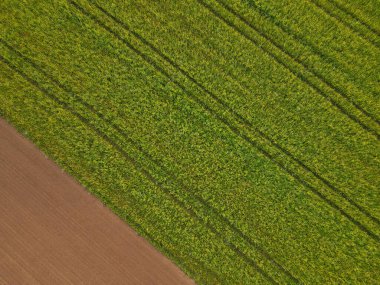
[{"xmin": 0, "ymin": 44, "xmax": 278, "ymax": 284}]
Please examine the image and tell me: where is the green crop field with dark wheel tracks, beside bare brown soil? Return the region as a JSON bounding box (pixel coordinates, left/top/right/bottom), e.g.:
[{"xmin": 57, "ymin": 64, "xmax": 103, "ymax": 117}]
[{"xmin": 0, "ymin": 0, "xmax": 380, "ymax": 284}]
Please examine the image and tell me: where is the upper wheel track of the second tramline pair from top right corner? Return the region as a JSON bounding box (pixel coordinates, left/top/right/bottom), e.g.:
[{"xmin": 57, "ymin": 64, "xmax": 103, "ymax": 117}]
[{"xmin": 212, "ymin": 0, "xmax": 380, "ymax": 125}]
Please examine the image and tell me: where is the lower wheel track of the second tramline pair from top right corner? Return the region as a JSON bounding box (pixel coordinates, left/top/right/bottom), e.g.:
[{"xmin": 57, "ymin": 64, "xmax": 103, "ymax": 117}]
[{"xmin": 196, "ymin": 0, "xmax": 380, "ymax": 140}]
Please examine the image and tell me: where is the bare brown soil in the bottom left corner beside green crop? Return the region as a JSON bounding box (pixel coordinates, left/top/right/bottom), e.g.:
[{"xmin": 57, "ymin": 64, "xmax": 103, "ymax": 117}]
[{"xmin": 0, "ymin": 116, "xmax": 193, "ymax": 285}]
